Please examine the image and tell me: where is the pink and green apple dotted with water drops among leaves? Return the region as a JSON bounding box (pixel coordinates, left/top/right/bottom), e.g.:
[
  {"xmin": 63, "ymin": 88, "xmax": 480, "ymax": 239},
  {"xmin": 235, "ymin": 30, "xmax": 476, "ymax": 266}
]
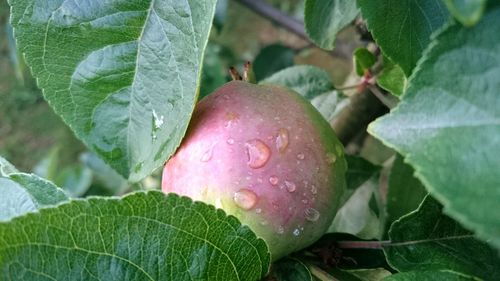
[{"xmin": 162, "ymin": 81, "xmax": 346, "ymax": 260}]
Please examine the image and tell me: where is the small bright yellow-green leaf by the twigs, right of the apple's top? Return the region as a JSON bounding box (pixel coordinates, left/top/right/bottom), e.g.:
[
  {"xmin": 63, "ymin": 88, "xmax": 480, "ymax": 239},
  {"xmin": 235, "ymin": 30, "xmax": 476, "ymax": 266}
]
[{"xmin": 377, "ymin": 58, "xmax": 406, "ymax": 97}]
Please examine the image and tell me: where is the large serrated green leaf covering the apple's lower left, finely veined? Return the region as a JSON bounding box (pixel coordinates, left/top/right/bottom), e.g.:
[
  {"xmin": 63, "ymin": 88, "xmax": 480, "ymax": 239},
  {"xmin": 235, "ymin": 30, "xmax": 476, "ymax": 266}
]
[{"xmin": 0, "ymin": 192, "xmax": 270, "ymax": 280}]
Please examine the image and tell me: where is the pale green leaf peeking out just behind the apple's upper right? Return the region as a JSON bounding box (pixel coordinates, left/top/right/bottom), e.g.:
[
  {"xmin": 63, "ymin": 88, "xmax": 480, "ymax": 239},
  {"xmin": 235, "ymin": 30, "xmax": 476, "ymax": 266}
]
[{"xmin": 259, "ymin": 65, "xmax": 334, "ymax": 100}]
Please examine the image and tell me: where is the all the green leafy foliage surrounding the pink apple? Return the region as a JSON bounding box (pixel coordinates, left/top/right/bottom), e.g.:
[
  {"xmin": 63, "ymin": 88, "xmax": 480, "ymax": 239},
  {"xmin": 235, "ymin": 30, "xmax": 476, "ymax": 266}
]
[{"xmin": 0, "ymin": 0, "xmax": 500, "ymax": 281}]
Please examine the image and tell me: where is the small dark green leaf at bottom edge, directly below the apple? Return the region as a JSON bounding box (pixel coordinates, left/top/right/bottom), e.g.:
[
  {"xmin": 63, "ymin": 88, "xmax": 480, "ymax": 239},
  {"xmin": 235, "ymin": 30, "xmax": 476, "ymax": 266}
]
[{"xmin": 266, "ymin": 258, "xmax": 314, "ymax": 281}]
